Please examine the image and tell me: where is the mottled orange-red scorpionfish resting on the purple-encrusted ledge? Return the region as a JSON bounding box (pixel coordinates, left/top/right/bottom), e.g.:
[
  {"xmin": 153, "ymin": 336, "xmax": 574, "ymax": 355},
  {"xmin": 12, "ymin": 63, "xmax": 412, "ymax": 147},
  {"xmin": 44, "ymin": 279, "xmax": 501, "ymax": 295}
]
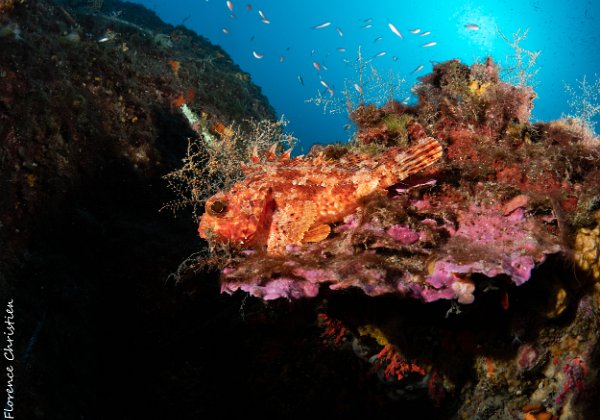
[{"xmin": 198, "ymin": 137, "xmax": 442, "ymax": 255}]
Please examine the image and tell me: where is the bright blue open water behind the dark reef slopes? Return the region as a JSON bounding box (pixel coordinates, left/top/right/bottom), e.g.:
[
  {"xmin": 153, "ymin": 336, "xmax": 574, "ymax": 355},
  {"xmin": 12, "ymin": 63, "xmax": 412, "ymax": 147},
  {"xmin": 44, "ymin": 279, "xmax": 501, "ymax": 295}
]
[{"xmin": 132, "ymin": 0, "xmax": 600, "ymax": 152}]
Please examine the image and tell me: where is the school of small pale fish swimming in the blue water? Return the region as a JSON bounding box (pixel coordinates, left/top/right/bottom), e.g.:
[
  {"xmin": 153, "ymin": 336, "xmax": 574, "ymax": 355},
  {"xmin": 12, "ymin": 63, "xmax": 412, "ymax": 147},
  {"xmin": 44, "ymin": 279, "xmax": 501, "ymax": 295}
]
[{"xmin": 212, "ymin": 0, "xmax": 480, "ymax": 96}]
